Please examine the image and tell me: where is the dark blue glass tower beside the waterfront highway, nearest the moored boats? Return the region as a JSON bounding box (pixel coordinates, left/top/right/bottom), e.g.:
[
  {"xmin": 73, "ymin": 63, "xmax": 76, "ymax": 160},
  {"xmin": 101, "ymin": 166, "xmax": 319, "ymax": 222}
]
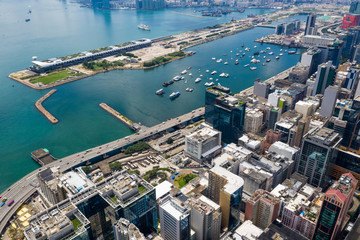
[{"xmin": 205, "ymin": 87, "xmax": 246, "ymax": 143}]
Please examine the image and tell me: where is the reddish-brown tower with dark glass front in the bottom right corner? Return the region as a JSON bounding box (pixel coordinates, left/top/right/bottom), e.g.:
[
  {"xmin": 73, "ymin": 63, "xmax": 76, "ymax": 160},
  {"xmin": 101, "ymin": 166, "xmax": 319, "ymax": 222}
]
[{"xmin": 312, "ymin": 173, "xmax": 358, "ymax": 240}]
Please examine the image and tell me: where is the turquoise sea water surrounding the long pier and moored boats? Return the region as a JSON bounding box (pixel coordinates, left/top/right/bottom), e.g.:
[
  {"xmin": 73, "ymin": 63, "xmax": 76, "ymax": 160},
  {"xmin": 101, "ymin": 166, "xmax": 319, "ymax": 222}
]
[{"xmin": 0, "ymin": 0, "xmax": 305, "ymax": 192}]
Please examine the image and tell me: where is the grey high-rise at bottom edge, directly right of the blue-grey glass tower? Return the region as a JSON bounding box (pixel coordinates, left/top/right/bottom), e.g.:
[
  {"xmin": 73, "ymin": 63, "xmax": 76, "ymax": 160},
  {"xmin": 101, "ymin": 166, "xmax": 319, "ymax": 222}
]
[{"xmin": 186, "ymin": 196, "xmax": 221, "ymax": 240}]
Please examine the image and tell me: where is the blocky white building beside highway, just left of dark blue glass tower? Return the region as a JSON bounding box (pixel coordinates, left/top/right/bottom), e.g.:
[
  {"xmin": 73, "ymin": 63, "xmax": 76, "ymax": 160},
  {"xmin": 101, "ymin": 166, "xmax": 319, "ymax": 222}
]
[{"xmin": 184, "ymin": 126, "xmax": 221, "ymax": 163}]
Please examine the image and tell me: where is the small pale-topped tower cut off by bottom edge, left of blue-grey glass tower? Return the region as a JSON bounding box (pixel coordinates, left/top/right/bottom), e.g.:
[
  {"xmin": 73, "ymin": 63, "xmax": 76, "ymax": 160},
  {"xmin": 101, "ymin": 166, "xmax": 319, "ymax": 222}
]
[{"xmin": 114, "ymin": 218, "xmax": 146, "ymax": 240}]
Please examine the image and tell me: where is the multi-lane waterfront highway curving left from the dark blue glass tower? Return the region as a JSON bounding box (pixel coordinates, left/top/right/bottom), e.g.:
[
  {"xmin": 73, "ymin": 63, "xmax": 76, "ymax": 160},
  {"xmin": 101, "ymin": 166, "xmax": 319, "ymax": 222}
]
[{"xmin": 0, "ymin": 107, "xmax": 205, "ymax": 233}]
